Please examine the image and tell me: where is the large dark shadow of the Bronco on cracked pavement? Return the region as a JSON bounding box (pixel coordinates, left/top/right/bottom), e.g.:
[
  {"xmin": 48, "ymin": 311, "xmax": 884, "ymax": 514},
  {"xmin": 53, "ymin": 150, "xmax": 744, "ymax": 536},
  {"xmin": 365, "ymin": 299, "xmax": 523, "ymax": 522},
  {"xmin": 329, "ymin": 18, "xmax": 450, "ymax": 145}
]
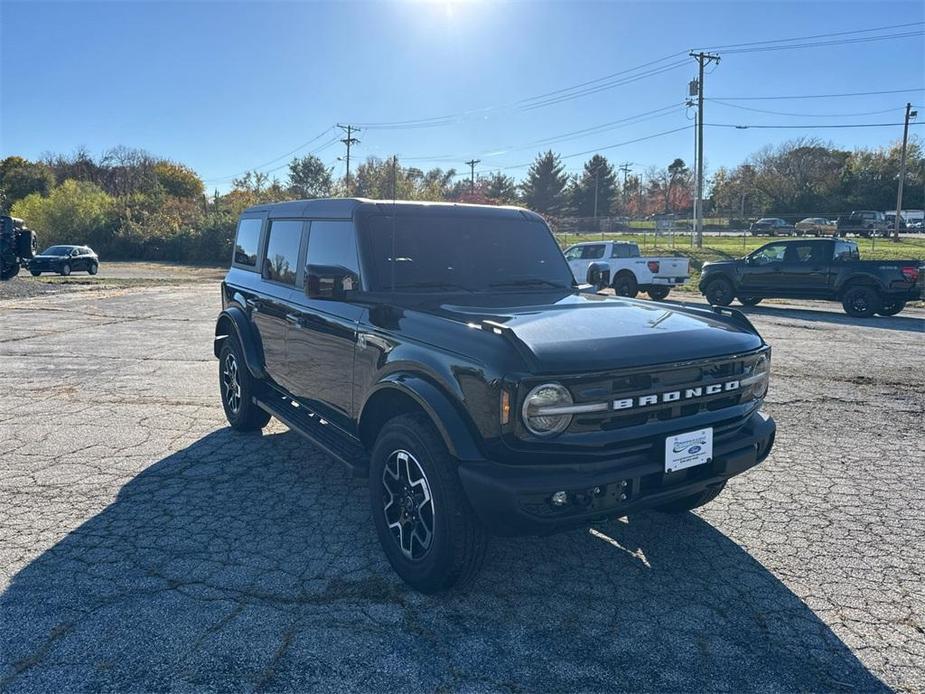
[{"xmin": 0, "ymin": 429, "xmax": 886, "ymax": 691}]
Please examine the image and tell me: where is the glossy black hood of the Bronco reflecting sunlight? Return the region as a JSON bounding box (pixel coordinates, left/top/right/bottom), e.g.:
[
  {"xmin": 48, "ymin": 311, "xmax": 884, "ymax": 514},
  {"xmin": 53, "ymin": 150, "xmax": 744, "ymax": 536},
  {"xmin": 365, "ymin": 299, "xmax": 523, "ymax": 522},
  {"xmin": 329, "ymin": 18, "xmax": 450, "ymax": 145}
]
[{"xmin": 422, "ymin": 292, "xmax": 764, "ymax": 373}]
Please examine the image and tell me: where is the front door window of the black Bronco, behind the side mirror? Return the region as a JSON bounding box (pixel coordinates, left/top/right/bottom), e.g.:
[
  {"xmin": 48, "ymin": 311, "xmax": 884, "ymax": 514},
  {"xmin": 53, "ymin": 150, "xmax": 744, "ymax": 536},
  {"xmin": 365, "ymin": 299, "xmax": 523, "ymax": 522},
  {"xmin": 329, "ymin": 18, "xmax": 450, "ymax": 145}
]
[{"xmin": 305, "ymin": 221, "xmax": 359, "ymax": 298}]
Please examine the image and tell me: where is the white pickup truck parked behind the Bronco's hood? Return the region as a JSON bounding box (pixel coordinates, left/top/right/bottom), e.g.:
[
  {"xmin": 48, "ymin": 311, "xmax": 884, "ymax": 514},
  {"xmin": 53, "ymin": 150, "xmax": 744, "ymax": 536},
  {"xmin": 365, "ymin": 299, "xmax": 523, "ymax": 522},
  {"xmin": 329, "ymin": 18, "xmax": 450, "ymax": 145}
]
[{"xmin": 565, "ymin": 241, "xmax": 691, "ymax": 301}]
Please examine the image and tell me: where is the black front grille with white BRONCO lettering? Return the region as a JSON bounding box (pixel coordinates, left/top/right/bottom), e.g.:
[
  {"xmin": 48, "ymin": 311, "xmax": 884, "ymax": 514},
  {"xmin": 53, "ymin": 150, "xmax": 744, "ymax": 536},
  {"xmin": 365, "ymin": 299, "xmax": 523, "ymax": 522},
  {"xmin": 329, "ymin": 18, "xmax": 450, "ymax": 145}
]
[{"xmin": 563, "ymin": 350, "xmax": 767, "ymax": 433}]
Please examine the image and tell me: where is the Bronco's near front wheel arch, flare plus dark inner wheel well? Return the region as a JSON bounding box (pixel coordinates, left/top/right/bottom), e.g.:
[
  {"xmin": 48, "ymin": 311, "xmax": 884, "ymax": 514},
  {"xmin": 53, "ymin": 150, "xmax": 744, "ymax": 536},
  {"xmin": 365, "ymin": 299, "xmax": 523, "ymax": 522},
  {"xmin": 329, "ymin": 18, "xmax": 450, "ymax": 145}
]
[{"xmin": 358, "ymin": 373, "xmax": 484, "ymax": 460}]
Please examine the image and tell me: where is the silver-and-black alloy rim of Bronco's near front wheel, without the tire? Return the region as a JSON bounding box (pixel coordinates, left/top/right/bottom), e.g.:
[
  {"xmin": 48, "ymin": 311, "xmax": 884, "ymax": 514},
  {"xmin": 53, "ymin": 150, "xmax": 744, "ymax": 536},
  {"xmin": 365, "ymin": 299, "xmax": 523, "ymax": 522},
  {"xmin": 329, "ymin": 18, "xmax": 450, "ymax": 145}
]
[{"xmin": 382, "ymin": 450, "xmax": 434, "ymax": 561}]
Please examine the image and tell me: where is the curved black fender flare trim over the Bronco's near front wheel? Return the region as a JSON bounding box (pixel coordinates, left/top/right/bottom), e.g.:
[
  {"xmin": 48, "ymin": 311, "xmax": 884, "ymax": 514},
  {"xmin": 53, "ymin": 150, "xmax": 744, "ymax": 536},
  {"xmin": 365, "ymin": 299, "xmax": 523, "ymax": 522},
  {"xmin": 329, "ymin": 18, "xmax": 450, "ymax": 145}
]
[{"xmin": 360, "ymin": 372, "xmax": 485, "ymax": 461}]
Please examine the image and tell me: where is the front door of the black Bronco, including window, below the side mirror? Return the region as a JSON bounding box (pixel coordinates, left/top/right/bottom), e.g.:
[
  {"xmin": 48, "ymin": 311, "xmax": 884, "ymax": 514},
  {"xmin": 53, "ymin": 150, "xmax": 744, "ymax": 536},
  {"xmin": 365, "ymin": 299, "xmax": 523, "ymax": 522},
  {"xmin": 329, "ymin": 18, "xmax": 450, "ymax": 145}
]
[{"xmin": 287, "ymin": 220, "xmax": 363, "ymax": 434}]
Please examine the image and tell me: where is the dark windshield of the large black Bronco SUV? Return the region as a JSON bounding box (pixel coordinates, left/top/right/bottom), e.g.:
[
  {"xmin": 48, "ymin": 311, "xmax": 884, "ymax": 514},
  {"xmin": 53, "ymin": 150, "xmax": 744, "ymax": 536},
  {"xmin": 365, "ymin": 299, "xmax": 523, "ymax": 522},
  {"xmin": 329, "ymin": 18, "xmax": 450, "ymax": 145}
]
[{"xmin": 361, "ymin": 215, "xmax": 574, "ymax": 292}]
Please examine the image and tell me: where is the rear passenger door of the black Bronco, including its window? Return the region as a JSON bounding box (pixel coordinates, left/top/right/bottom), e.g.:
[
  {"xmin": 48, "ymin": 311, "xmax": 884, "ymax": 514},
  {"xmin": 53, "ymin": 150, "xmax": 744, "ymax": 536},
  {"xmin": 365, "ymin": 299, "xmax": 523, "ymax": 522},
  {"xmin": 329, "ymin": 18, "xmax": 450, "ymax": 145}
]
[{"xmin": 249, "ymin": 219, "xmax": 305, "ymax": 389}]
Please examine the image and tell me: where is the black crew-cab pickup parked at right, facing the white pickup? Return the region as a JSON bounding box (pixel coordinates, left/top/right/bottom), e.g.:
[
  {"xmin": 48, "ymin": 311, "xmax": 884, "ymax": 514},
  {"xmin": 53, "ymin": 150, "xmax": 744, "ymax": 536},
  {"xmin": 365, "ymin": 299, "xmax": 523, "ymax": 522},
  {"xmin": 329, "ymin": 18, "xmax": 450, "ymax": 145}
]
[{"xmin": 700, "ymin": 239, "xmax": 925, "ymax": 317}]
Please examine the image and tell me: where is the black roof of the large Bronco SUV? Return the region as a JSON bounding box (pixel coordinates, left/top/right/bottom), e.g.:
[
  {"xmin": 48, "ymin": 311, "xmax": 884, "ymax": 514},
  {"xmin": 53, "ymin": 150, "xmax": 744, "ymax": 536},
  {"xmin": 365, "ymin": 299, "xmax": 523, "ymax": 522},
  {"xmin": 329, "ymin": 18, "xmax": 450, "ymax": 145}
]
[{"xmin": 243, "ymin": 198, "xmax": 543, "ymax": 221}]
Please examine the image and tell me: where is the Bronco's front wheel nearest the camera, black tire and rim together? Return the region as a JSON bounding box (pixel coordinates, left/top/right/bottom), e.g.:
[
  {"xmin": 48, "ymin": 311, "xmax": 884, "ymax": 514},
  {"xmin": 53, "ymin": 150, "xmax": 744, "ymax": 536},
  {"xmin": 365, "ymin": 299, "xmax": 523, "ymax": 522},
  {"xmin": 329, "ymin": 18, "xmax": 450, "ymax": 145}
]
[{"xmin": 369, "ymin": 413, "xmax": 488, "ymax": 593}]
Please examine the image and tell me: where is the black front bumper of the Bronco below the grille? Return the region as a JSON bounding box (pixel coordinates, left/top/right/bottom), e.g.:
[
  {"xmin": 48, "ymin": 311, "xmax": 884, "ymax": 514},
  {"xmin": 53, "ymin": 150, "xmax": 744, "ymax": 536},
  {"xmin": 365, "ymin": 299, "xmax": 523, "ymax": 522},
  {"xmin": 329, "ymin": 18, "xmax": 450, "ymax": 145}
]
[{"xmin": 459, "ymin": 412, "xmax": 777, "ymax": 535}]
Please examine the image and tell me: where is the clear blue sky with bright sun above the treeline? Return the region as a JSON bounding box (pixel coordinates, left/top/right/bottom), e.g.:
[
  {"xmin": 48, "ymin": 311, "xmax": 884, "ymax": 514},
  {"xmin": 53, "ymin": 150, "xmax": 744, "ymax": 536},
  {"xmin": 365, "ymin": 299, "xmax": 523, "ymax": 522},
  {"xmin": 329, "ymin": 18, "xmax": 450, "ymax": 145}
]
[{"xmin": 0, "ymin": 0, "xmax": 925, "ymax": 190}]
